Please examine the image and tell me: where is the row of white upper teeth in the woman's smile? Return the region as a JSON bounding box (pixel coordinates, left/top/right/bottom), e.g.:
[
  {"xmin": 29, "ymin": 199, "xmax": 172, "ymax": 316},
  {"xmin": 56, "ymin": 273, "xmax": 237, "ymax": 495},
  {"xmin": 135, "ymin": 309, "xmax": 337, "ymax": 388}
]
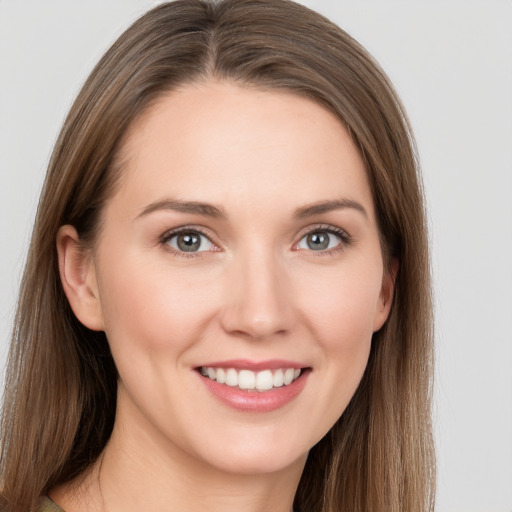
[{"xmin": 199, "ymin": 366, "xmax": 301, "ymax": 392}]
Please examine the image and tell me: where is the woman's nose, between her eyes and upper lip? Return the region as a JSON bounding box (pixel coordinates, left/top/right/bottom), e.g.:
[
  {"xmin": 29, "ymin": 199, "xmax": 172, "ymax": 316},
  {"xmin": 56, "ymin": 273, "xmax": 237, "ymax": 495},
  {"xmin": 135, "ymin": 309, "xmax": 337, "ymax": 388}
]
[{"xmin": 221, "ymin": 251, "xmax": 295, "ymax": 339}]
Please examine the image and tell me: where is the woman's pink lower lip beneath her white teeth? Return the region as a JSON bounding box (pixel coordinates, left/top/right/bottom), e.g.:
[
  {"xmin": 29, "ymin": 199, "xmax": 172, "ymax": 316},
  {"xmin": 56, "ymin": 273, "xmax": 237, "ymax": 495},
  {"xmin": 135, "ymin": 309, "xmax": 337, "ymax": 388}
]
[{"xmin": 198, "ymin": 370, "xmax": 310, "ymax": 412}]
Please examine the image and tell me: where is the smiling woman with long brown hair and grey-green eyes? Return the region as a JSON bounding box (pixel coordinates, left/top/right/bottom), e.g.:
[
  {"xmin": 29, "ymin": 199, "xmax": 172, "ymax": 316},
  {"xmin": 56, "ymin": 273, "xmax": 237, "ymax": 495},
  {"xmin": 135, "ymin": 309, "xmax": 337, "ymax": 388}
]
[{"xmin": 2, "ymin": 0, "xmax": 434, "ymax": 512}]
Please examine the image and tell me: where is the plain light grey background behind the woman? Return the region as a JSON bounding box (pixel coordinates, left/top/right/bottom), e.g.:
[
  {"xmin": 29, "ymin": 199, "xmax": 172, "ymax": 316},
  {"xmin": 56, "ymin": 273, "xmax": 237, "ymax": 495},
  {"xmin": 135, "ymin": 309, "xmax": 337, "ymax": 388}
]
[{"xmin": 0, "ymin": 0, "xmax": 512, "ymax": 512}]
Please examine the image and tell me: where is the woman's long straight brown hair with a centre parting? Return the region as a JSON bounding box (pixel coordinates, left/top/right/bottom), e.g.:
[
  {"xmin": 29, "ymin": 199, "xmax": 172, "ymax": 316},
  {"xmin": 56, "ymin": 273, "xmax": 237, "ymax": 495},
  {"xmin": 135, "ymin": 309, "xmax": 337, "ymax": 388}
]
[{"xmin": 1, "ymin": 0, "xmax": 435, "ymax": 512}]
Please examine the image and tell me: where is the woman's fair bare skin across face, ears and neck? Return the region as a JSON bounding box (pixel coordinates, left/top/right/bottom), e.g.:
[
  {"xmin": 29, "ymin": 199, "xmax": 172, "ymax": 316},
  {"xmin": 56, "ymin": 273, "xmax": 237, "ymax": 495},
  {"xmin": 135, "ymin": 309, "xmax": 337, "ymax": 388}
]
[{"xmin": 54, "ymin": 82, "xmax": 396, "ymax": 512}]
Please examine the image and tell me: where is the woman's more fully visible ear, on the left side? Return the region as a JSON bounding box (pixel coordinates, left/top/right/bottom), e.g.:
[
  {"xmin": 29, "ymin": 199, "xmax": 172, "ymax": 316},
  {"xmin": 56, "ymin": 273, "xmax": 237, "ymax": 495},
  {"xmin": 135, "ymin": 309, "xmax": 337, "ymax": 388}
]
[{"xmin": 57, "ymin": 225, "xmax": 104, "ymax": 331}]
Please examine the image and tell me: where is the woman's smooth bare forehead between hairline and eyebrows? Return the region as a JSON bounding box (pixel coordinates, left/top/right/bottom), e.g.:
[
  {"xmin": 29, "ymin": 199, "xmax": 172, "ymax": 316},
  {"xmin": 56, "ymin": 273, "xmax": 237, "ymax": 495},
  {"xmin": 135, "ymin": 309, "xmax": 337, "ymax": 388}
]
[{"xmin": 113, "ymin": 82, "xmax": 372, "ymax": 220}]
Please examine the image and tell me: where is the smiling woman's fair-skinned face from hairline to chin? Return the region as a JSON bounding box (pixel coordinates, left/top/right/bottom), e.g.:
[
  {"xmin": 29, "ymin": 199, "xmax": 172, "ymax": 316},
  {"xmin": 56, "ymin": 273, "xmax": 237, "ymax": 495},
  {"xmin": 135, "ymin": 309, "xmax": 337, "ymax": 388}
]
[{"xmin": 80, "ymin": 82, "xmax": 392, "ymax": 473}]
